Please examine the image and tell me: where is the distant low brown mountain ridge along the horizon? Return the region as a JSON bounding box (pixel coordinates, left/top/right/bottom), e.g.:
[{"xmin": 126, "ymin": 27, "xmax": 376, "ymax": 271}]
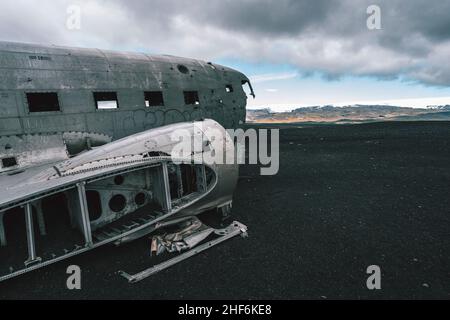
[{"xmin": 247, "ymin": 105, "xmax": 450, "ymax": 123}]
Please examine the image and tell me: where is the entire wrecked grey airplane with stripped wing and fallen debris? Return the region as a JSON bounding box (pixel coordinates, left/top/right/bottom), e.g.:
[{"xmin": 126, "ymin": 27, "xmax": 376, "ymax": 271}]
[{"xmin": 0, "ymin": 42, "xmax": 254, "ymax": 282}]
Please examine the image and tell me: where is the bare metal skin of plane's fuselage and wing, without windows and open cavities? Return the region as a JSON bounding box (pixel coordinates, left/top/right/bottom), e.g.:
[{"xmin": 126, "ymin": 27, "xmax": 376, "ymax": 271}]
[{"xmin": 0, "ymin": 42, "xmax": 250, "ymax": 280}]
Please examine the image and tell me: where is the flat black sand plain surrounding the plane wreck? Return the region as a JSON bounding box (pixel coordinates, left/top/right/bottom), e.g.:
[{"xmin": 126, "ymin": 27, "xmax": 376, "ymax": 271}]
[{"xmin": 0, "ymin": 122, "xmax": 450, "ymax": 299}]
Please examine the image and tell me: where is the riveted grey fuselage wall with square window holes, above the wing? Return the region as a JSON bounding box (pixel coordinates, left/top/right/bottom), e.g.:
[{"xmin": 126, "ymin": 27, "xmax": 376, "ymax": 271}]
[{"xmin": 0, "ymin": 42, "xmax": 248, "ymax": 140}]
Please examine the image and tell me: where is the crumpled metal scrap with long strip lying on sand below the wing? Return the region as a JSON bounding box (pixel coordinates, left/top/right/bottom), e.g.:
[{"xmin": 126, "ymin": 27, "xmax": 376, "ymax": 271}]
[{"xmin": 118, "ymin": 217, "xmax": 247, "ymax": 283}]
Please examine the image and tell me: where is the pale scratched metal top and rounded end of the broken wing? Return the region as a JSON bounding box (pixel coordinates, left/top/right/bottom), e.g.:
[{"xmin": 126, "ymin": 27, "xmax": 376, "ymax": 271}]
[{"xmin": 0, "ymin": 120, "xmax": 238, "ymax": 212}]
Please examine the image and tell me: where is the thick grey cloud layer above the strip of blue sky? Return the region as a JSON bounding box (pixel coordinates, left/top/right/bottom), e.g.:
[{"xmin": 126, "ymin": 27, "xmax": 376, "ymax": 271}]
[{"xmin": 0, "ymin": 0, "xmax": 450, "ymax": 86}]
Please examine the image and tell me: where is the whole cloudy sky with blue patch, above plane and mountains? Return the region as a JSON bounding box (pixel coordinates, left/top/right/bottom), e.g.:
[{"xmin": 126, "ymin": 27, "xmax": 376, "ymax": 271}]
[{"xmin": 0, "ymin": 0, "xmax": 450, "ymax": 109}]
